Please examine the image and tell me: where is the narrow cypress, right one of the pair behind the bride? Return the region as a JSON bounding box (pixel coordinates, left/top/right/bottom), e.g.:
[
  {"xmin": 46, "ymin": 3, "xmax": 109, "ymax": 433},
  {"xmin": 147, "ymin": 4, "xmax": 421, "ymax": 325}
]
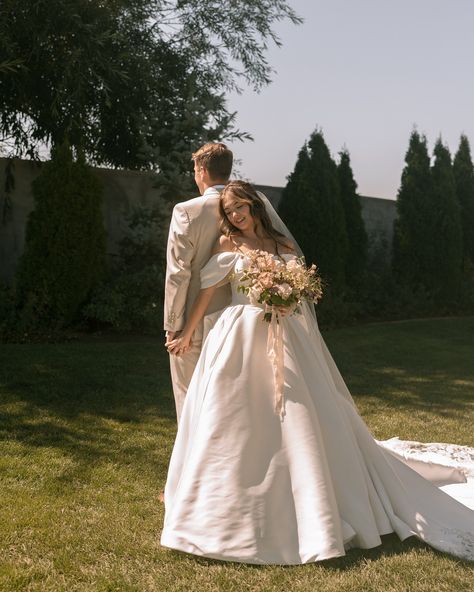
[{"xmin": 337, "ymin": 150, "xmax": 367, "ymax": 288}]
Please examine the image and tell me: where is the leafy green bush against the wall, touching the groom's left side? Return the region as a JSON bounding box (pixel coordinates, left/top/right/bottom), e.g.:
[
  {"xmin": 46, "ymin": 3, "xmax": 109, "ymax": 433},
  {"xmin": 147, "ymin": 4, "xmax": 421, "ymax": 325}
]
[{"xmin": 84, "ymin": 200, "xmax": 170, "ymax": 333}]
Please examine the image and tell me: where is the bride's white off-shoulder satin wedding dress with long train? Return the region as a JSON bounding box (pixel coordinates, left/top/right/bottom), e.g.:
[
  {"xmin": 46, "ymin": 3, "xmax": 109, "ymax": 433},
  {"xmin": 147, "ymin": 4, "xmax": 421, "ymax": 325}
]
[{"xmin": 161, "ymin": 252, "xmax": 474, "ymax": 564}]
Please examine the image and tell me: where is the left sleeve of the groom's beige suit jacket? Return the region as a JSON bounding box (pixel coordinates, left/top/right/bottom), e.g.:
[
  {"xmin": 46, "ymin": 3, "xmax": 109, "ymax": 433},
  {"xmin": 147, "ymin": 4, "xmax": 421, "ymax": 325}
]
[{"xmin": 164, "ymin": 204, "xmax": 194, "ymax": 331}]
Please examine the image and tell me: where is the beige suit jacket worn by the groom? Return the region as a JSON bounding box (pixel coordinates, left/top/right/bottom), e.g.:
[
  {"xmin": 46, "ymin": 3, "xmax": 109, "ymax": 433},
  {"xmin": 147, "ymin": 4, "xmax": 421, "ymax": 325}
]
[{"xmin": 164, "ymin": 187, "xmax": 231, "ymax": 341}]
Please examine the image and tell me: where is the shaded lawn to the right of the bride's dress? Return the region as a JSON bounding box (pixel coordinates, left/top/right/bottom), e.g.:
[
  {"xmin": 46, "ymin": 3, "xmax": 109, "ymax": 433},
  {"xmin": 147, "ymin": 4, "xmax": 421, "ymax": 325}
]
[{"xmin": 325, "ymin": 317, "xmax": 474, "ymax": 417}]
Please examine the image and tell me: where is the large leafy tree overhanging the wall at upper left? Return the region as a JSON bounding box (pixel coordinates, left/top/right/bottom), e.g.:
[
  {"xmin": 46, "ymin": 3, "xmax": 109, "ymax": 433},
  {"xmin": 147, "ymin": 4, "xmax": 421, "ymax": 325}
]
[{"xmin": 0, "ymin": 0, "xmax": 300, "ymax": 175}]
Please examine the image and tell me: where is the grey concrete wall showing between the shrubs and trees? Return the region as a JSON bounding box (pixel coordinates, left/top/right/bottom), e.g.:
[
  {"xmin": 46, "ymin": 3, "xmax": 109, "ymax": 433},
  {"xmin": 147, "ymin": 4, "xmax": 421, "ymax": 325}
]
[{"xmin": 0, "ymin": 158, "xmax": 395, "ymax": 282}]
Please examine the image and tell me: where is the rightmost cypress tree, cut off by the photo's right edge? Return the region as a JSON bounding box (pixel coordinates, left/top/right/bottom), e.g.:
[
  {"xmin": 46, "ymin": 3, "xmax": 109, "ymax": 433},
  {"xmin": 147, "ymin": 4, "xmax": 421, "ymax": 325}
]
[{"xmin": 453, "ymin": 135, "xmax": 474, "ymax": 269}]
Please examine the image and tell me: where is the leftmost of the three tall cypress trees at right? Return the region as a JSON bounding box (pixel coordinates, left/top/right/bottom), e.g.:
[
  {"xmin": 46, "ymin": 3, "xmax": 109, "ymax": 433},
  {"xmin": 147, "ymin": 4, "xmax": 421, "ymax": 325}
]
[{"xmin": 392, "ymin": 130, "xmax": 434, "ymax": 289}]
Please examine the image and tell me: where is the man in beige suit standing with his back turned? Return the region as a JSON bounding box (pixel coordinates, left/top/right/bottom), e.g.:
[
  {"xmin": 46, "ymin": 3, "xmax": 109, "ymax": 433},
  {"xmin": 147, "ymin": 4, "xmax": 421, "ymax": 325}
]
[{"xmin": 164, "ymin": 143, "xmax": 233, "ymax": 423}]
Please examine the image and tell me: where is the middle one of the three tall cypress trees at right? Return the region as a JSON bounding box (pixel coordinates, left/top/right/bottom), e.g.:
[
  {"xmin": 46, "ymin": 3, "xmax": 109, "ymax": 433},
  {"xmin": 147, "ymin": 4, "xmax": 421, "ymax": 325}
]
[{"xmin": 431, "ymin": 138, "xmax": 463, "ymax": 303}]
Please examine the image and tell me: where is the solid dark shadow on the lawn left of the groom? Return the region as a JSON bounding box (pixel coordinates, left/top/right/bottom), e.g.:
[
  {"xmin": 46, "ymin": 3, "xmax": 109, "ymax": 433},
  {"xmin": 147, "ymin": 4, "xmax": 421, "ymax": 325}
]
[{"xmin": 0, "ymin": 342, "xmax": 175, "ymax": 422}]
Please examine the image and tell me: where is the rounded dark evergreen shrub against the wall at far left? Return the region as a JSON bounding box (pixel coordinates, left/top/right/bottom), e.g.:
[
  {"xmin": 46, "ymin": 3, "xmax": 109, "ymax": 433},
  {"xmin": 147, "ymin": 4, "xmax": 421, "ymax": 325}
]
[{"xmin": 15, "ymin": 143, "xmax": 106, "ymax": 330}]
